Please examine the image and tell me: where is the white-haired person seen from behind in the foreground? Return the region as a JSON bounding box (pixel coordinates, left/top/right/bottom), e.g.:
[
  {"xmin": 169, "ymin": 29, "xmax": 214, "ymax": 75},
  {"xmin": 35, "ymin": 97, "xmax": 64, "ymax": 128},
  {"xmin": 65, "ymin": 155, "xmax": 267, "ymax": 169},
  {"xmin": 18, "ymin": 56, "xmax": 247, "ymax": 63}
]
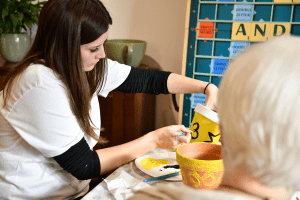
[{"xmin": 127, "ymin": 36, "xmax": 300, "ymax": 200}]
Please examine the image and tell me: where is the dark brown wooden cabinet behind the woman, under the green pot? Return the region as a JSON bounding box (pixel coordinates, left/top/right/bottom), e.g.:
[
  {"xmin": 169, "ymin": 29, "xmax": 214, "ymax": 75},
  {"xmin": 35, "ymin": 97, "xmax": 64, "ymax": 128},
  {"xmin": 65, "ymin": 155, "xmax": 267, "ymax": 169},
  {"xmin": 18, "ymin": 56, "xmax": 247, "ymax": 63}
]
[{"xmin": 0, "ymin": 57, "xmax": 155, "ymax": 149}]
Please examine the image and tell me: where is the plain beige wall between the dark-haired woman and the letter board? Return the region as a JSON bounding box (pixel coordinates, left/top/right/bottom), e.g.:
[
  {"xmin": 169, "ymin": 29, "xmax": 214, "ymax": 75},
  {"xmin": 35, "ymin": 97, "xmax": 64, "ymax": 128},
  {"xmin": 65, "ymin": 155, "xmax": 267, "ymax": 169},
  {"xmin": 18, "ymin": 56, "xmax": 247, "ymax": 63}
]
[{"xmin": 32, "ymin": 0, "xmax": 187, "ymax": 128}]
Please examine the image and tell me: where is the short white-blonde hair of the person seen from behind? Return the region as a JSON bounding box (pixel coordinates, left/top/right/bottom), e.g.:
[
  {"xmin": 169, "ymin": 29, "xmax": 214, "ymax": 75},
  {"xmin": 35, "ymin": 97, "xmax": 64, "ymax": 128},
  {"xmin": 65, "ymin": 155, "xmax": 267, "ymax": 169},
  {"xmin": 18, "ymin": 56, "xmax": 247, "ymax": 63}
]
[{"xmin": 218, "ymin": 36, "xmax": 300, "ymax": 188}]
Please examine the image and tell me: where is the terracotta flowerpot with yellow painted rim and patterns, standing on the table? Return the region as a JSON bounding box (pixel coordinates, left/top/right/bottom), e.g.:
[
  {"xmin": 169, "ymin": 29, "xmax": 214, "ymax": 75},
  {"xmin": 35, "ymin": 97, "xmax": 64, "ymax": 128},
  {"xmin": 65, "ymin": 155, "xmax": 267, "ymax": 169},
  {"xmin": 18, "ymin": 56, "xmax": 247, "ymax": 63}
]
[{"xmin": 176, "ymin": 143, "xmax": 224, "ymax": 189}]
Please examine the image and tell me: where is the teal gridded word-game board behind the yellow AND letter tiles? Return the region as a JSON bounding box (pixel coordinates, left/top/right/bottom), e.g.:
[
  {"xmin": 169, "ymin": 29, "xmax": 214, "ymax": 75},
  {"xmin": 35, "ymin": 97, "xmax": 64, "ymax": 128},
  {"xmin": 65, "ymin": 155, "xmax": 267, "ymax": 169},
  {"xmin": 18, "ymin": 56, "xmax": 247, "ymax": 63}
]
[{"xmin": 181, "ymin": 0, "xmax": 300, "ymax": 127}]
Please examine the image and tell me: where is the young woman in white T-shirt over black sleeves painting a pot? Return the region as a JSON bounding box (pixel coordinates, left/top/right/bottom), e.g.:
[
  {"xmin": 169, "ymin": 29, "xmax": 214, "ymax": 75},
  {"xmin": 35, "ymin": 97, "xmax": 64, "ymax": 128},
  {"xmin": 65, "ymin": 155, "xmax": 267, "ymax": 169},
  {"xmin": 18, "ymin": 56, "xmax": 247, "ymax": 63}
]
[{"xmin": 0, "ymin": 0, "xmax": 218, "ymax": 199}]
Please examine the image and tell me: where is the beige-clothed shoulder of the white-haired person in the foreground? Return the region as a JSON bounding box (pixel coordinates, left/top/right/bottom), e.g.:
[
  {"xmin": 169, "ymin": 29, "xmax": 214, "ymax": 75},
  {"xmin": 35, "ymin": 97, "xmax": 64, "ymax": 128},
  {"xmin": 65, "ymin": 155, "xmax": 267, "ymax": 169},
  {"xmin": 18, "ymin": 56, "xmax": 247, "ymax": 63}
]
[{"xmin": 129, "ymin": 184, "xmax": 246, "ymax": 200}]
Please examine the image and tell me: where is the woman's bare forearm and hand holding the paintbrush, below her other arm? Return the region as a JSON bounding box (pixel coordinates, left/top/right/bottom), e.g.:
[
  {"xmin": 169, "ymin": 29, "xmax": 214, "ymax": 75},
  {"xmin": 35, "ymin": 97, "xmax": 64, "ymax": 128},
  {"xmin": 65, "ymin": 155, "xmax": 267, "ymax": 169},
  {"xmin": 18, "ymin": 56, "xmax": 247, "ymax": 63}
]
[{"xmin": 96, "ymin": 125, "xmax": 191, "ymax": 174}]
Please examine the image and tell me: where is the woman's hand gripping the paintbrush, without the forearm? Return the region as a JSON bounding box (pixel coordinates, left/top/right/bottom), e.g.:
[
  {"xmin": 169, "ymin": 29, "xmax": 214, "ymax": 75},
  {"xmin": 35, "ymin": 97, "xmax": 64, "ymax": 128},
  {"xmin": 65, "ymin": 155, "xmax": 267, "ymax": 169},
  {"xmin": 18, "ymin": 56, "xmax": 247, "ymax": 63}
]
[{"xmin": 151, "ymin": 125, "xmax": 191, "ymax": 150}]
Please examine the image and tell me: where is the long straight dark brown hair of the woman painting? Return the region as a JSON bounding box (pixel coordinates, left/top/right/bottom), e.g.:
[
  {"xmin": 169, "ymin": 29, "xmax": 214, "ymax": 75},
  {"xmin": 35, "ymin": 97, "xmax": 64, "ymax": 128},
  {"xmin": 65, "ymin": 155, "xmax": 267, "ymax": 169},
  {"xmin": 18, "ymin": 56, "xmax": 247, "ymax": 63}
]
[{"xmin": 0, "ymin": 0, "xmax": 112, "ymax": 143}]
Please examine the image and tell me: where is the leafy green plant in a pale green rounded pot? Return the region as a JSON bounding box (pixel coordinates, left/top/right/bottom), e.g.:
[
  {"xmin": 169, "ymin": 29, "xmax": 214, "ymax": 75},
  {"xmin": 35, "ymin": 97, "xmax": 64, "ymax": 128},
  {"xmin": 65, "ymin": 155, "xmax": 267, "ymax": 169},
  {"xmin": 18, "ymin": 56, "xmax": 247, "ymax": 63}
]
[{"xmin": 0, "ymin": 0, "xmax": 45, "ymax": 62}]
